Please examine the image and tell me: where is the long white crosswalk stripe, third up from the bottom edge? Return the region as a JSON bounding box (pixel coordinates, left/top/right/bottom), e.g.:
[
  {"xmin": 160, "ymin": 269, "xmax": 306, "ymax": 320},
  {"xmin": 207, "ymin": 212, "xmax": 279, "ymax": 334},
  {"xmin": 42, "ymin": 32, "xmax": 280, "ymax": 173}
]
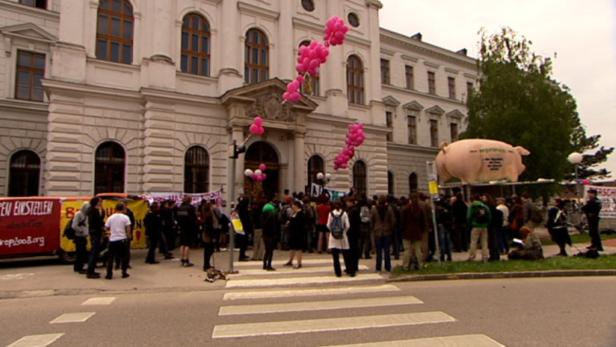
[{"xmin": 218, "ymin": 296, "xmax": 422, "ymax": 316}]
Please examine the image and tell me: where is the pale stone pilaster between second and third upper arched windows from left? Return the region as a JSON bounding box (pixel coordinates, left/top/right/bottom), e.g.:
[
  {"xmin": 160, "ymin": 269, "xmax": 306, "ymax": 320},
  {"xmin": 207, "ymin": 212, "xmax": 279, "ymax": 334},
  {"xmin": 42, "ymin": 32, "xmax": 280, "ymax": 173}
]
[{"xmin": 219, "ymin": 0, "xmax": 244, "ymax": 95}]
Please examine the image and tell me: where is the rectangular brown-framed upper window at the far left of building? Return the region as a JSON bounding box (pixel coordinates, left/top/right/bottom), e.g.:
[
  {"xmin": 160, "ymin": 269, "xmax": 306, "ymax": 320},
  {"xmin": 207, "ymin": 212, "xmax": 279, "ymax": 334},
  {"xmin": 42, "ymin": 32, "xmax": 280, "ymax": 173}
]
[{"xmin": 15, "ymin": 51, "xmax": 45, "ymax": 101}]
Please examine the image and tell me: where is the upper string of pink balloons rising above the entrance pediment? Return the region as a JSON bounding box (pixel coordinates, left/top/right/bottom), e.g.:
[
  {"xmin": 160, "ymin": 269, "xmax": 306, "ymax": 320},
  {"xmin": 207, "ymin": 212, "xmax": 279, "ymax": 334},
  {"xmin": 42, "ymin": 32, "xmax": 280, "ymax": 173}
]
[{"xmin": 282, "ymin": 16, "xmax": 349, "ymax": 102}]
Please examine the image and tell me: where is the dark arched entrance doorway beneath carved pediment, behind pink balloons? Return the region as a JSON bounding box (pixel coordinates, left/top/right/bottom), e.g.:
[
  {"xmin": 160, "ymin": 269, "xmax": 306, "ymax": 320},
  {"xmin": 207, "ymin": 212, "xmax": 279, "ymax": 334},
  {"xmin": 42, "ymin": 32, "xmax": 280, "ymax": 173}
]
[{"xmin": 244, "ymin": 141, "xmax": 280, "ymax": 200}]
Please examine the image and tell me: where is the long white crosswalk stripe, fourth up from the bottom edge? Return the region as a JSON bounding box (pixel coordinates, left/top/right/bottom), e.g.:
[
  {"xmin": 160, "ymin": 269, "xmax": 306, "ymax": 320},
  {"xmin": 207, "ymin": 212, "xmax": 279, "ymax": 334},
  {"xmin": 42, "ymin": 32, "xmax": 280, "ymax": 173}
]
[{"xmin": 223, "ymin": 284, "xmax": 400, "ymax": 301}]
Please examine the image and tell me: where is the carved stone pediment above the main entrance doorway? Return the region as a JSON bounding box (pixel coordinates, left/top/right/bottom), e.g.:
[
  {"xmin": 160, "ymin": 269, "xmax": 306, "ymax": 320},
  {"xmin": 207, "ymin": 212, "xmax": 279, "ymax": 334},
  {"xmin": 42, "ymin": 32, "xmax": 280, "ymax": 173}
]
[{"xmin": 221, "ymin": 78, "xmax": 318, "ymax": 122}]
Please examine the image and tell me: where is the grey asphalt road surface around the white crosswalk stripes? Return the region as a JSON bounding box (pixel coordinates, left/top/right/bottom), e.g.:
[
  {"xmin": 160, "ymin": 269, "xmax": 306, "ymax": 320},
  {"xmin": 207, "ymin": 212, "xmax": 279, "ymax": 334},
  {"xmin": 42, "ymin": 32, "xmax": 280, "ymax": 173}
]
[{"xmin": 0, "ymin": 257, "xmax": 616, "ymax": 347}]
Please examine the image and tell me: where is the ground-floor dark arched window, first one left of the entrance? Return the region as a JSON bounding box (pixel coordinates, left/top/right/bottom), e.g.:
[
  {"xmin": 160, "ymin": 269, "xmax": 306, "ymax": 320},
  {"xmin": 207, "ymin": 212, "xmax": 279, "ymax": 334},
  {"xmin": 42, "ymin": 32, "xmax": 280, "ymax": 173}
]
[{"xmin": 184, "ymin": 146, "xmax": 210, "ymax": 193}]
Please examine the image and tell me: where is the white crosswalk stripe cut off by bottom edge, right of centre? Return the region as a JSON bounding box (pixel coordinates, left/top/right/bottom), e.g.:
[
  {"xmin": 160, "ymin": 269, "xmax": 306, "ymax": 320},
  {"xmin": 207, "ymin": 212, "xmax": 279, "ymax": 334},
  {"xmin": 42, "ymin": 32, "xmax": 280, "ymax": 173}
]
[{"xmin": 327, "ymin": 334, "xmax": 505, "ymax": 347}]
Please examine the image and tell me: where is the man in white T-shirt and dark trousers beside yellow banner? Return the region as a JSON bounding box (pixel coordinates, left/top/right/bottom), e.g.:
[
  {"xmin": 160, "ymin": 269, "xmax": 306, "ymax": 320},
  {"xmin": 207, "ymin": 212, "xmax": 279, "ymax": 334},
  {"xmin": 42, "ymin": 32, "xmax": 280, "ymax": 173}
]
[{"xmin": 105, "ymin": 203, "xmax": 130, "ymax": 280}]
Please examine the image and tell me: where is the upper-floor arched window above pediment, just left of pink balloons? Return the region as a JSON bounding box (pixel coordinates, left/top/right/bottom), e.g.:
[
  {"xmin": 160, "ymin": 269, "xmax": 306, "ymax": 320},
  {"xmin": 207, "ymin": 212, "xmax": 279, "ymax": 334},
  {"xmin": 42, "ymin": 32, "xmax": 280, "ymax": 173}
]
[{"xmin": 244, "ymin": 29, "xmax": 269, "ymax": 83}]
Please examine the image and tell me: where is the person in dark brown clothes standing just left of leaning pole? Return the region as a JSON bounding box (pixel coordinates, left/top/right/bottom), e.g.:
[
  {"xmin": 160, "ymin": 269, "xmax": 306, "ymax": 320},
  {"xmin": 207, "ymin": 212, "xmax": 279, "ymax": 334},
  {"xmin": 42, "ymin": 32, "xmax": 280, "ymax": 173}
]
[{"xmin": 400, "ymin": 194, "xmax": 428, "ymax": 270}]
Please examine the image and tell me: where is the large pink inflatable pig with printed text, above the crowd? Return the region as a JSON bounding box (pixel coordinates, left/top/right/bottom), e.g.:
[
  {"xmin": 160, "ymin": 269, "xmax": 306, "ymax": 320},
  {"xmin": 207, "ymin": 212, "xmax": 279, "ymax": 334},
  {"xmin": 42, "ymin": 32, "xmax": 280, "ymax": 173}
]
[{"xmin": 436, "ymin": 139, "xmax": 530, "ymax": 183}]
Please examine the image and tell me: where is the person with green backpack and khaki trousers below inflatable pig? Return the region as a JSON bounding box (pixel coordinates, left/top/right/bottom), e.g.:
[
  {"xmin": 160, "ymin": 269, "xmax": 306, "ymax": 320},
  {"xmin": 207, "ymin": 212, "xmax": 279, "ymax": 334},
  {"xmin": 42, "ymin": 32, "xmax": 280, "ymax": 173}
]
[{"xmin": 467, "ymin": 195, "xmax": 492, "ymax": 262}]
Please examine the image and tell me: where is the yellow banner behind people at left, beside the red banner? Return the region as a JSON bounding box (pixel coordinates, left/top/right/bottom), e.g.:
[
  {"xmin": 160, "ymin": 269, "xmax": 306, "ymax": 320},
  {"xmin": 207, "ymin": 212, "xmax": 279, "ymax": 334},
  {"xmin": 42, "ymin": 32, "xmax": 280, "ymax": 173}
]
[{"xmin": 60, "ymin": 199, "xmax": 148, "ymax": 252}]
